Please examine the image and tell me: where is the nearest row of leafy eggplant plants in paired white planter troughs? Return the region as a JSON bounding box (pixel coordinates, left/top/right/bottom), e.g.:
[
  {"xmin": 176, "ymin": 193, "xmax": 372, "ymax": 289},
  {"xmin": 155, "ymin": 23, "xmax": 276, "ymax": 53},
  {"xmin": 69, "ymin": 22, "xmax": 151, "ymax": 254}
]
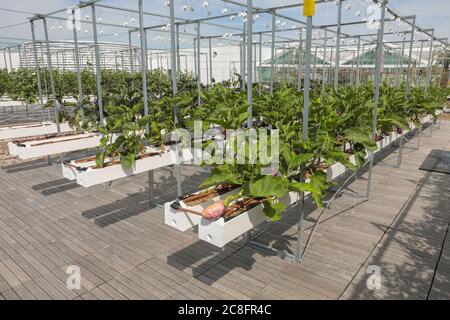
[{"xmin": 165, "ymin": 83, "xmax": 447, "ymax": 247}]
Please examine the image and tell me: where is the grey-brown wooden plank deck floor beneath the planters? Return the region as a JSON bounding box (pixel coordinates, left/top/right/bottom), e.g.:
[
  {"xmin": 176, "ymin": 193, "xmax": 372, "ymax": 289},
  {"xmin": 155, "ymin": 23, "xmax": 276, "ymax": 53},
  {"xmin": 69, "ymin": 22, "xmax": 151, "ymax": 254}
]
[{"xmin": 0, "ymin": 118, "xmax": 450, "ymax": 299}]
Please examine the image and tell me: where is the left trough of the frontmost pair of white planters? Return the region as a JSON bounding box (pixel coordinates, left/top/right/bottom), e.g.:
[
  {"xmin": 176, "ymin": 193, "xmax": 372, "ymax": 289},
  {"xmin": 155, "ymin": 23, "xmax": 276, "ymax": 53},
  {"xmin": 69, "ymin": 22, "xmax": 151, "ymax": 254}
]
[{"xmin": 164, "ymin": 189, "xmax": 240, "ymax": 232}]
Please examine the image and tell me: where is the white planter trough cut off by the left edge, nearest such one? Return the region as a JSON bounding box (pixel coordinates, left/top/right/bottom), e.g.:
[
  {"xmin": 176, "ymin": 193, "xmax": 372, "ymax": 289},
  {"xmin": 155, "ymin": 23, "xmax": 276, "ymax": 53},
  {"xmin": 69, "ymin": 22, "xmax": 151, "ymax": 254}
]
[{"xmin": 0, "ymin": 122, "xmax": 74, "ymax": 140}]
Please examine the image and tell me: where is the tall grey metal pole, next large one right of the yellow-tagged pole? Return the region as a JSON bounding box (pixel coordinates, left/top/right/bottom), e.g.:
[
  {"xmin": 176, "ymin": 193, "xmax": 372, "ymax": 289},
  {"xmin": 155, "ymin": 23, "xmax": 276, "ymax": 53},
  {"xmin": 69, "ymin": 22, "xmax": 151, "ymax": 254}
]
[{"xmin": 366, "ymin": 1, "xmax": 386, "ymax": 198}]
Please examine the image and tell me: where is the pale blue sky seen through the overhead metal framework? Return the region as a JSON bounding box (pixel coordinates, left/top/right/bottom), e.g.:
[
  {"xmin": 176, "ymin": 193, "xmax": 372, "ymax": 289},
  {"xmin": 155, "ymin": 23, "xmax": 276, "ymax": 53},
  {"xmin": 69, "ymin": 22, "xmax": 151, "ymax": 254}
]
[{"xmin": 0, "ymin": 0, "xmax": 450, "ymax": 48}]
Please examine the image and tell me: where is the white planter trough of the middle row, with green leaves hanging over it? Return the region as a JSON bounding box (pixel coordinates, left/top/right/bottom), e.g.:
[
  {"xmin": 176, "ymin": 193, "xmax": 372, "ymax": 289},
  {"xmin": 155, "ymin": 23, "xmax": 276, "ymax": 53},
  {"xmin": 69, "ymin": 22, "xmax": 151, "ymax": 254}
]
[{"xmin": 67, "ymin": 148, "xmax": 192, "ymax": 188}]
